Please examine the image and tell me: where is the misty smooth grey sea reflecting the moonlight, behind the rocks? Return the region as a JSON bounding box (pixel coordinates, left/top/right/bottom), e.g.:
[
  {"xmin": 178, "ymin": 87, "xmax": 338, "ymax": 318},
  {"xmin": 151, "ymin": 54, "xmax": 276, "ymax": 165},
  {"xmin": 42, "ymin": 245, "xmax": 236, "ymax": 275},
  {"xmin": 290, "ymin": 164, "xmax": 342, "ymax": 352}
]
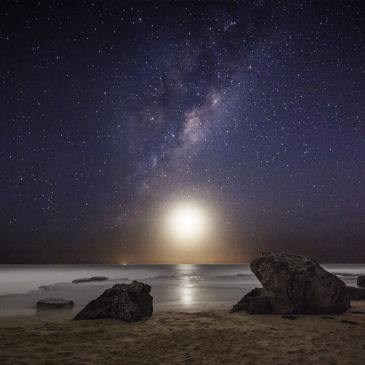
[{"xmin": 0, "ymin": 264, "xmax": 365, "ymax": 316}]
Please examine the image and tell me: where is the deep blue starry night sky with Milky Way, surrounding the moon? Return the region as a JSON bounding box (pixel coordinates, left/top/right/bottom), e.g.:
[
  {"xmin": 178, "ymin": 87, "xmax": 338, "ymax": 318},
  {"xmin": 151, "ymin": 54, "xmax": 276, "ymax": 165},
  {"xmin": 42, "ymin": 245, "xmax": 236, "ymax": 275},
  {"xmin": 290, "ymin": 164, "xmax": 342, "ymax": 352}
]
[{"xmin": 0, "ymin": 0, "xmax": 365, "ymax": 263}]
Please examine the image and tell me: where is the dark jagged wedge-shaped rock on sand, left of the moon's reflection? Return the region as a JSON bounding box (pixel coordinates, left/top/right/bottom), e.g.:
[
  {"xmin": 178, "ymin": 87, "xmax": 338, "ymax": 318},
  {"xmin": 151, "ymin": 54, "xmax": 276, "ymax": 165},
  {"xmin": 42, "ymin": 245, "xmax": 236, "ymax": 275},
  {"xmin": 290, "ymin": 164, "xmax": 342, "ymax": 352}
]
[{"xmin": 74, "ymin": 281, "xmax": 153, "ymax": 322}]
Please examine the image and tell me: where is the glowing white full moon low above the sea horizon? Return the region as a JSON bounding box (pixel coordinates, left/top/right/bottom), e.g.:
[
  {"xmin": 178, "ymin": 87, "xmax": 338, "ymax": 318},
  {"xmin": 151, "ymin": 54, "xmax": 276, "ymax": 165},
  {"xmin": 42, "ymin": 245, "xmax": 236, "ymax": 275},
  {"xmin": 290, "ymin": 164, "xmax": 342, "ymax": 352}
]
[{"xmin": 167, "ymin": 203, "xmax": 208, "ymax": 242}]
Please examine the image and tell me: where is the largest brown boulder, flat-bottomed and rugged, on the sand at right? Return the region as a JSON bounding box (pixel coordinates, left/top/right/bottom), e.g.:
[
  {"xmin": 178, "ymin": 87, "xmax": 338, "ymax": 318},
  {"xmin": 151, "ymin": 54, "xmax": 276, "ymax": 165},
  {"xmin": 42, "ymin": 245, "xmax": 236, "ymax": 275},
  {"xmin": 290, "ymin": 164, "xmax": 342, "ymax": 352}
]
[{"xmin": 233, "ymin": 253, "xmax": 350, "ymax": 314}]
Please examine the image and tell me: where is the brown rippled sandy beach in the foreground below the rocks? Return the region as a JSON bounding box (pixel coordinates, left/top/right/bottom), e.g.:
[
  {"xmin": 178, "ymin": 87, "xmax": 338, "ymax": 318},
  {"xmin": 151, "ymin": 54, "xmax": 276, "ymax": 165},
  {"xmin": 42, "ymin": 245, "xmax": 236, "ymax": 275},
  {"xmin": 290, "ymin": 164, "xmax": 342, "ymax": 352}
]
[{"xmin": 0, "ymin": 302, "xmax": 365, "ymax": 365}]
